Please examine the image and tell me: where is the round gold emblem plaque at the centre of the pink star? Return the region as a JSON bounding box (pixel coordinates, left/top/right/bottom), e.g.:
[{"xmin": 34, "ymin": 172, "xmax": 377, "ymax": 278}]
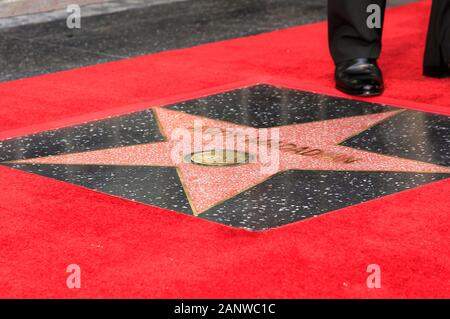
[{"xmin": 185, "ymin": 150, "xmax": 251, "ymax": 166}]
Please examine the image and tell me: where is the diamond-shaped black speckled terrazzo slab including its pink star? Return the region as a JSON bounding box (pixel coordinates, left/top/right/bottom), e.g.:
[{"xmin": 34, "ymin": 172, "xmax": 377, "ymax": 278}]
[{"xmin": 0, "ymin": 85, "xmax": 450, "ymax": 230}]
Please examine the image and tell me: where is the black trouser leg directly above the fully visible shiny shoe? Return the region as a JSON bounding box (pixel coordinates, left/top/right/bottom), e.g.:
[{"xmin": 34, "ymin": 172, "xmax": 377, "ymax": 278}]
[{"xmin": 328, "ymin": 0, "xmax": 386, "ymax": 63}]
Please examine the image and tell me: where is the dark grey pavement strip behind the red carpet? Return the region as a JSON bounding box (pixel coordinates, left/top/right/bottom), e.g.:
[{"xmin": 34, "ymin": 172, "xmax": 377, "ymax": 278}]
[{"xmin": 0, "ymin": 0, "xmax": 414, "ymax": 82}]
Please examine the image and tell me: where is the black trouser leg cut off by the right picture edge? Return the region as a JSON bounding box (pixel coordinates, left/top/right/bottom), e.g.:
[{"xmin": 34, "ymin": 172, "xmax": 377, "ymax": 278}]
[{"xmin": 423, "ymin": 0, "xmax": 450, "ymax": 77}]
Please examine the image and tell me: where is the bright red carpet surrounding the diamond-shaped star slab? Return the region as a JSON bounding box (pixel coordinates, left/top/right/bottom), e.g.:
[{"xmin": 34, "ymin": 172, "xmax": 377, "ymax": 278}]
[{"xmin": 0, "ymin": 1, "xmax": 450, "ymax": 298}]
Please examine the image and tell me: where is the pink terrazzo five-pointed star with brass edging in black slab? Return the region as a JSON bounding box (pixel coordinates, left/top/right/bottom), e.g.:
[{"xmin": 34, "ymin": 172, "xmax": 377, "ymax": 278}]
[{"xmin": 15, "ymin": 108, "xmax": 450, "ymax": 215}]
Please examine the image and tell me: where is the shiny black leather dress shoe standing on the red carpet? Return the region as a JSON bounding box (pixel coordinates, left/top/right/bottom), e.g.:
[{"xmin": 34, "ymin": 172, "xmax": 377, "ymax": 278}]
[{"xmin": 335, "ymin": 58, "xmax": 384, "ymax": 96}]
